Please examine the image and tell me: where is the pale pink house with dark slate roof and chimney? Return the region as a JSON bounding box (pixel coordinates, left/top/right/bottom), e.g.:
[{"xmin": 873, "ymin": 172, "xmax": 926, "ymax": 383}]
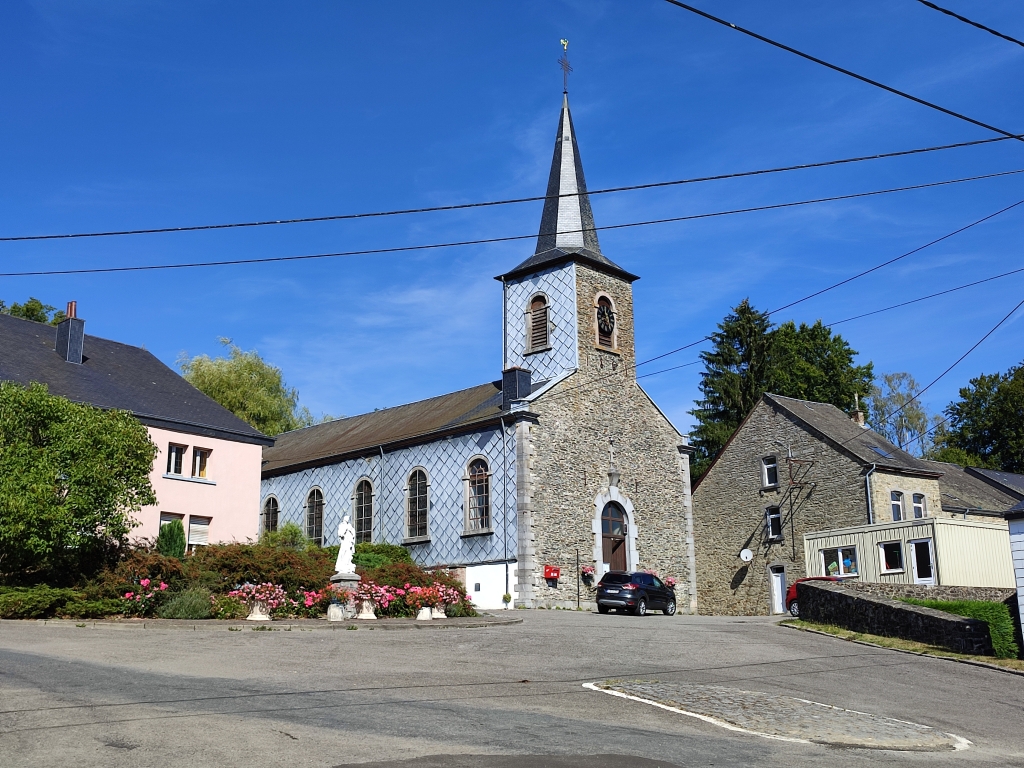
[{"xmin": 0, "ymin": 302, "xmax": 273, "ymax": 546}]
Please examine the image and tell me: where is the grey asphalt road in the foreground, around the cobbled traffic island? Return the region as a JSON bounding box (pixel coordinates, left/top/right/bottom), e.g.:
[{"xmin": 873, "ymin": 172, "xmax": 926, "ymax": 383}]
[{"xmin": 0, "ymin": 611, "xmax": 1024, "ymax": 768}]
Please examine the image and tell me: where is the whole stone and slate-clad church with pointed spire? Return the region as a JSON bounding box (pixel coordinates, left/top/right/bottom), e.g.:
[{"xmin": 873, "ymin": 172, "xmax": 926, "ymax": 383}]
[{"xmin": 260, "ymin": 94, "xmax": 696, "ymax": 612}]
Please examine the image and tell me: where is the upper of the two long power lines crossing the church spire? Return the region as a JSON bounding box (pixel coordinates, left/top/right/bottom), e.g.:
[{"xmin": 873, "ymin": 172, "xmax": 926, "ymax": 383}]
[{"xmin": 0, "ymin": 134, "xmax": 1024, "ymax": 243}]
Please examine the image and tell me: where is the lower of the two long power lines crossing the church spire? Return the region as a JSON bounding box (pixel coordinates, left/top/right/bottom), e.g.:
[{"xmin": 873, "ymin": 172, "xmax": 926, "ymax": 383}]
[{"xmin": 0, "ymin": 168, "xmax": 1024, "ymax": 280}]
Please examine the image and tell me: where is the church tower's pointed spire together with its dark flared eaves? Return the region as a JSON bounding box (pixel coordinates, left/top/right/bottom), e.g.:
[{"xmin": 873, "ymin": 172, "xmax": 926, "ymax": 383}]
[{"xmin": 498, "ymin": 95, "xmax": 639, "ymax": 283}]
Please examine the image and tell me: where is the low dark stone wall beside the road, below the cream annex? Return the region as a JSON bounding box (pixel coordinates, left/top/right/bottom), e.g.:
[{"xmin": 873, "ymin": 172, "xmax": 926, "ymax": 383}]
[{"xmin": 797, "ymin": 582, "xmax": 992, "ymax": 656}]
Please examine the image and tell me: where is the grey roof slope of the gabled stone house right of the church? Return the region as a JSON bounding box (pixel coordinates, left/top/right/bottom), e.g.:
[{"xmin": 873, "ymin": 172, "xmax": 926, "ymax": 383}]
[{"xmin": 764, "ymin": 394, "xmax": 941, "ymax": 476}]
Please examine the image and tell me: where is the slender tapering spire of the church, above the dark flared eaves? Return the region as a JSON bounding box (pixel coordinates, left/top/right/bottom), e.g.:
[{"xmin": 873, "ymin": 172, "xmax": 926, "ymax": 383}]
[{"xmin": 535, "ymin": 94, "xmax": 601, "ymax": 255}]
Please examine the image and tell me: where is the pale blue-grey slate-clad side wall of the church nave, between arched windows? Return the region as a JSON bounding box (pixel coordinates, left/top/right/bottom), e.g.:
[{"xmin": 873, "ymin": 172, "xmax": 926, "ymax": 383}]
[{"xmin": 260, "ymin": 426, "xmax": 516, "ymax": 566}]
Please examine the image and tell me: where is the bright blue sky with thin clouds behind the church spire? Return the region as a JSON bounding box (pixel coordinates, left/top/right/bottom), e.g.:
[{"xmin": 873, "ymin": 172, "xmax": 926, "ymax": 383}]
[{"xmin": 0, "ymin": 0, "xmax": 1024, "ymax": 429}]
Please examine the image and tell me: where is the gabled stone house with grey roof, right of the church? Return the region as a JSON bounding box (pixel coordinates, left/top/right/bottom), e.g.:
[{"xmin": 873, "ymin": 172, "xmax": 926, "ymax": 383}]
[{"xmin": 693, "ymin": 394, "xmax": 1018, "ymax": 614}]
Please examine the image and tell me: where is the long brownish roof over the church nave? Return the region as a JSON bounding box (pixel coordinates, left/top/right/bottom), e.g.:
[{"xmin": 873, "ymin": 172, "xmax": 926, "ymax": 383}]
[{"xmin": 263, "ymin": 381, "xmax": 507, "ymax": 477}]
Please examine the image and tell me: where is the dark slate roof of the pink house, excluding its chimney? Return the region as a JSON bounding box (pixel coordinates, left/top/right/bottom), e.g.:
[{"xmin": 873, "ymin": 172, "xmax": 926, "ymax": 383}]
[{"xmin": 0, "ymin": 314, "xmax": 273, "ymax": 445}]
